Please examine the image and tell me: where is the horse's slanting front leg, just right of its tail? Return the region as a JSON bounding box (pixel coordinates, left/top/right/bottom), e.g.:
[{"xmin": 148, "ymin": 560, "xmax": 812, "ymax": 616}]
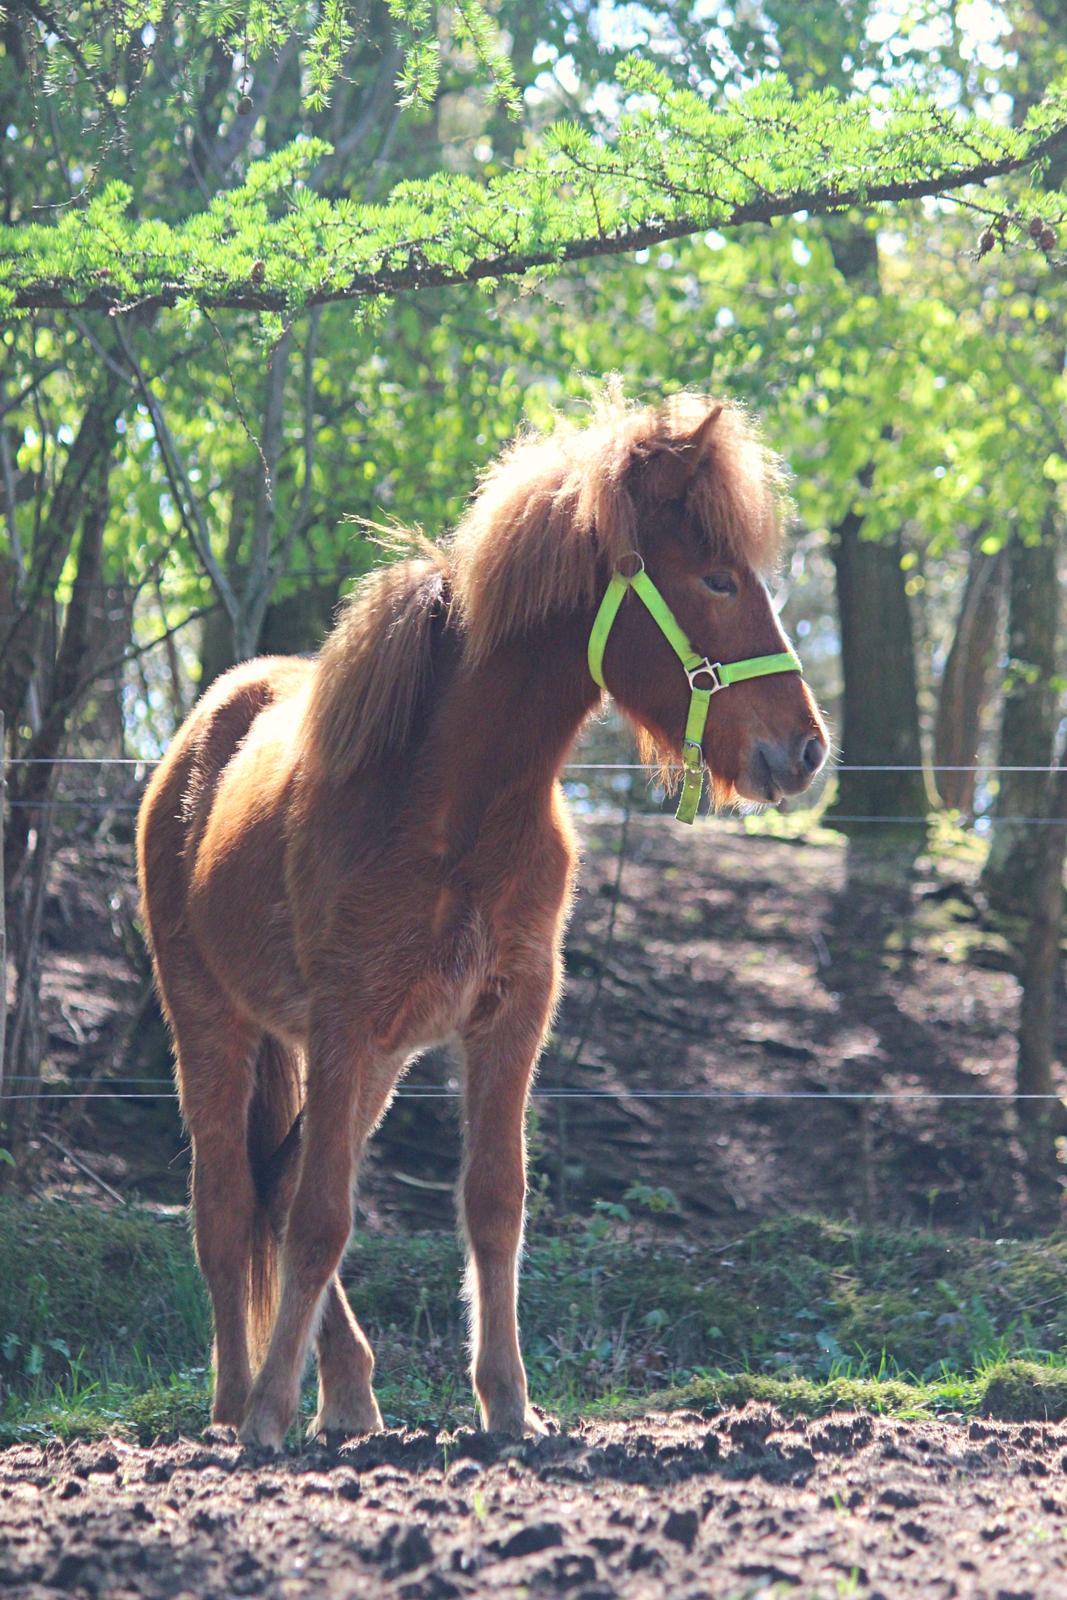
[{"xmin": 240, "ymin": 1042, "xmax": 400, "ymax": 1450}]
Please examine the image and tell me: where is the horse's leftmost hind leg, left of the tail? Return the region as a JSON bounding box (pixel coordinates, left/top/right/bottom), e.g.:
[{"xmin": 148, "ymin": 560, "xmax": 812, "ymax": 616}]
[{"xmin": 173, "ymin": 989, "xmax": 259, "ymax": 1427}]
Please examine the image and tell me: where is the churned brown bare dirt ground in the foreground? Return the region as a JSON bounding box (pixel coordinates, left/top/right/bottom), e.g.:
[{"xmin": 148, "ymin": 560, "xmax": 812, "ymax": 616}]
[{"xmin": 0, "ymin": 1405, "xmax": 1067, "ymax": 1600}]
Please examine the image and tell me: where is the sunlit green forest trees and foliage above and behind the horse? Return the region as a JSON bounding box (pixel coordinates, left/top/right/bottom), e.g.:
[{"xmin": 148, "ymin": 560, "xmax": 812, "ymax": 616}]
[{"xmin": 0, "ymin": 0, "xmax": 1067, "ymax": 1177}]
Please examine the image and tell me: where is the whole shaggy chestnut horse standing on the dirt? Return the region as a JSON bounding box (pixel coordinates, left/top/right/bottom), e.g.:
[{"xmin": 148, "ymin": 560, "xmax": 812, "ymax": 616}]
[{"xmin": 138, "ymin": 395, "xmax": 827, "ymax": 1448}]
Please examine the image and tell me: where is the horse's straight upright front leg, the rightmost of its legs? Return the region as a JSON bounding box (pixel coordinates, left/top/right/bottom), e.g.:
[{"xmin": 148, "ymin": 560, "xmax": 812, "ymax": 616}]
[{"xmin": 459, "ymin": 971, "xmax": 555, "ymax": 1435}]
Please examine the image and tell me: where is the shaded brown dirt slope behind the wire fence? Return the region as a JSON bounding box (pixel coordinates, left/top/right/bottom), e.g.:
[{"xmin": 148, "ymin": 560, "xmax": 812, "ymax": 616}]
[{"xmin": 29, "ymin": 816, "xmax": 1067, "ymax": 1230}]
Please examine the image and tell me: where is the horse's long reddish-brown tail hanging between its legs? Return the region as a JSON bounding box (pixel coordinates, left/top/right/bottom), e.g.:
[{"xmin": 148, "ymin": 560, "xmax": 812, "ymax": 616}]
[{"xmin": 245, "ymin": 1034, "xmax": 302, "ymax": 1368}]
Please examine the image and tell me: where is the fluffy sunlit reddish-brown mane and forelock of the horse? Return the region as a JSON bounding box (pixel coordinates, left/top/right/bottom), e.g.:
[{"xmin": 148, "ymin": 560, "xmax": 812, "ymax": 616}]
[{"xmin": 306, "ymin": 390, "xmax": 782, "ymax": 779}]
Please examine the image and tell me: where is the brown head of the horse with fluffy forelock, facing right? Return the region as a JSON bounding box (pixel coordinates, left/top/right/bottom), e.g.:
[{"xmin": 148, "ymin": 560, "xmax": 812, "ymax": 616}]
[{"xmin": 603, "ymin": 397, "xmax": 827, "ymax": 803}]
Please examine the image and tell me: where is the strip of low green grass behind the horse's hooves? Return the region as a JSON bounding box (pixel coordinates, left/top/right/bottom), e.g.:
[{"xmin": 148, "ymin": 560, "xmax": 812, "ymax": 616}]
[{"xmin": 0, "ymin": 1197, "xmax": 1067, "ymax": 1442}]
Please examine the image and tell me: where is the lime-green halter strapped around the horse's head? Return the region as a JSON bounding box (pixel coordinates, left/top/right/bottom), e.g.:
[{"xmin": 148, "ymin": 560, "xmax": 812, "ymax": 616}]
[{"xmin": 589, "ymin": 552, "xmax": 803, "ymax": 822}]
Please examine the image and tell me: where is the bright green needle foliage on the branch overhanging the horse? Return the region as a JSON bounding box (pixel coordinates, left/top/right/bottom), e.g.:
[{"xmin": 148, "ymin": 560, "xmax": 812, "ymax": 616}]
[{"xmin": 0, "ymin": 0, "xmax": 1067, "ymax": 320}]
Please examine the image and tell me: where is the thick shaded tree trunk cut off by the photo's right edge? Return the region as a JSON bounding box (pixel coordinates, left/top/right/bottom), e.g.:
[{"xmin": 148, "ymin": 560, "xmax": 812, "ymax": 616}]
[{"xmin": 981, "ymin": 518, "xmax": 1059, "ymax": 915}]
